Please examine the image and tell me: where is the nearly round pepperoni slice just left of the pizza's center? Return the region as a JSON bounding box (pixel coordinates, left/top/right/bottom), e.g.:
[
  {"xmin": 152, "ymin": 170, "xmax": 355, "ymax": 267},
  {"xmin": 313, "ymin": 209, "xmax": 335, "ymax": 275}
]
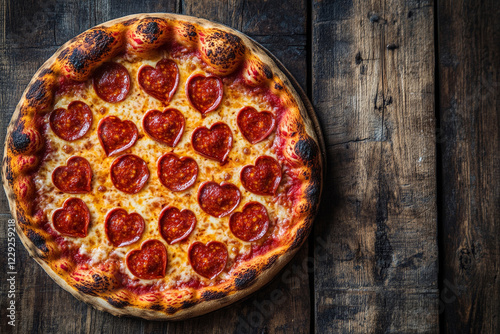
[{"xmin": 110, "ymin": 154, "xmax": 149, "ymax": 194}]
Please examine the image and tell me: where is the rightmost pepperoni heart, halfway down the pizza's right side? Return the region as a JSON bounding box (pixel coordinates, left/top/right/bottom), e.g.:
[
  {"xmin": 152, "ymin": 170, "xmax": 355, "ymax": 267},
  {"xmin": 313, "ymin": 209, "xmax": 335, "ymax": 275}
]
[{"xmin": 240, "ymin": 156, "xmax": 281, "ymax": 195}]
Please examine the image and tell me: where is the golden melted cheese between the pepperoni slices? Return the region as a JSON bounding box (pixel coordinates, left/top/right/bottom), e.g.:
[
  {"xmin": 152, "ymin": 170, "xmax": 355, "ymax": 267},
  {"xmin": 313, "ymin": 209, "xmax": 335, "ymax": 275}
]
[{"xmin": 35, "ymin": 54, "xmax": 290, "ymax": 288}]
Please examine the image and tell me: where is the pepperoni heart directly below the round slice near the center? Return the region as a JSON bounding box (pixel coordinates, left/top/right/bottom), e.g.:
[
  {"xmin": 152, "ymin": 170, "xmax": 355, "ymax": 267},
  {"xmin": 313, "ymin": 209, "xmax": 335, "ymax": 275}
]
[{"xmin": 104, "ymin": 208, "xmax": 144, "ymax": 247}]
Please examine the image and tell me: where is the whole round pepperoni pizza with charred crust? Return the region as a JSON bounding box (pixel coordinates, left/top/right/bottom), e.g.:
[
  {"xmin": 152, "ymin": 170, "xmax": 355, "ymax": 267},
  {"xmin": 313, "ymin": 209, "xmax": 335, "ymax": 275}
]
[{"xmin": 3, "ymin": 14, "xmax": 323, "ymax": 320}]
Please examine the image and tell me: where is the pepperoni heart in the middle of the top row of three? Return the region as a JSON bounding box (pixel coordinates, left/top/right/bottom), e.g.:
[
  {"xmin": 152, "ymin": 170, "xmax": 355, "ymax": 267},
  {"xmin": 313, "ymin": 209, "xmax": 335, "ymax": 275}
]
[{"xmin": 137, "ymin": 59, "xmax": 179, "ymax": 103}]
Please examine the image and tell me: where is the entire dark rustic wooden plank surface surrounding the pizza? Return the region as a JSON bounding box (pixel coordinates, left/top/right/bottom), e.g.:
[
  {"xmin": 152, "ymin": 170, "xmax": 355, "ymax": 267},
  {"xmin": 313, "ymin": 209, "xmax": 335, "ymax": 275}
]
[{"xmin": 0, "ymin": 0, "xmax": 500, "ymax": 333}]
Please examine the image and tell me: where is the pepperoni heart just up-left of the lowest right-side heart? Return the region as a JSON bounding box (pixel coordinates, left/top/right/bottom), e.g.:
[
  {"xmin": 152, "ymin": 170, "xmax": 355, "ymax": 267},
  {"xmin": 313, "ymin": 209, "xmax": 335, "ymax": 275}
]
[{"xmin": 198, "ymin": 182, "xmax": 241, "ymax": 218}]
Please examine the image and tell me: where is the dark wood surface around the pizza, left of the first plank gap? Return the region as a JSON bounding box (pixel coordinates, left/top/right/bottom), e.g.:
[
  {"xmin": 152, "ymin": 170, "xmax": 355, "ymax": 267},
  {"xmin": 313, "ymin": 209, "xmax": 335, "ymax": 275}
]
[{"xmin": 0, "ymin": 0, "xmax": 311, "ymax": 333}]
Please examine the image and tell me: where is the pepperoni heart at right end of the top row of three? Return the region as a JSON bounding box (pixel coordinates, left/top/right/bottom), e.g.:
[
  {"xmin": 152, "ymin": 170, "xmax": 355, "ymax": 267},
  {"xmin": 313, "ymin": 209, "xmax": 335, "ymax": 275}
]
[{"xmin": 186, "ymin": 74, "xmax": 224, "ymax": 116}]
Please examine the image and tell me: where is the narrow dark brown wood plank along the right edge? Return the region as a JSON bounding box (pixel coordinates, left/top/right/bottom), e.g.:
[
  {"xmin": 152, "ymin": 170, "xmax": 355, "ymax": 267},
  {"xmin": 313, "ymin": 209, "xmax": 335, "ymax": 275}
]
[{"xmin": 438, "ymin": 0, "xmax": 500, "ymax": 333}]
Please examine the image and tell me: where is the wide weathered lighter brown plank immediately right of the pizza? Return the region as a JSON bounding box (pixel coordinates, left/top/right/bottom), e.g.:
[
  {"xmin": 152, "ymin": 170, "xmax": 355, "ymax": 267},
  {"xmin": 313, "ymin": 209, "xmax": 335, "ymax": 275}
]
[{"xmin": 312, "ymin": 0, "xmax": 438, "ymax": 333}]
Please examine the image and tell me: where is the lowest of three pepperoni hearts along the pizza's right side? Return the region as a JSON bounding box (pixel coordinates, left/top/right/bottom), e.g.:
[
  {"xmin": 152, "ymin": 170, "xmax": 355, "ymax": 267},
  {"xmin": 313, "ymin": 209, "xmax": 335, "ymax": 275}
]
[{"xmin": 229, "ymin": 202, "xmax": 269, "ymax": 241}]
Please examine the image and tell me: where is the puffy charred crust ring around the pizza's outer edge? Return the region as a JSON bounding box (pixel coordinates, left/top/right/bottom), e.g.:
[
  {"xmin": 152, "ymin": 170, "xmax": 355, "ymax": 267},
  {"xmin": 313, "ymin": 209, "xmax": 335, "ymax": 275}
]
[{"xmin": 3, "ymin": 14, "xmax": 322, "ymax": 320}]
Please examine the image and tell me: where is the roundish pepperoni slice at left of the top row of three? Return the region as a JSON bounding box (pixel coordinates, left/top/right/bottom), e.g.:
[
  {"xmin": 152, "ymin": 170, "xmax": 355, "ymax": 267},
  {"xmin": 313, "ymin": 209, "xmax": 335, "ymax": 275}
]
[{"xmin": 94, "ymin": 63, "xmax": 130, "ymax": 103}]
